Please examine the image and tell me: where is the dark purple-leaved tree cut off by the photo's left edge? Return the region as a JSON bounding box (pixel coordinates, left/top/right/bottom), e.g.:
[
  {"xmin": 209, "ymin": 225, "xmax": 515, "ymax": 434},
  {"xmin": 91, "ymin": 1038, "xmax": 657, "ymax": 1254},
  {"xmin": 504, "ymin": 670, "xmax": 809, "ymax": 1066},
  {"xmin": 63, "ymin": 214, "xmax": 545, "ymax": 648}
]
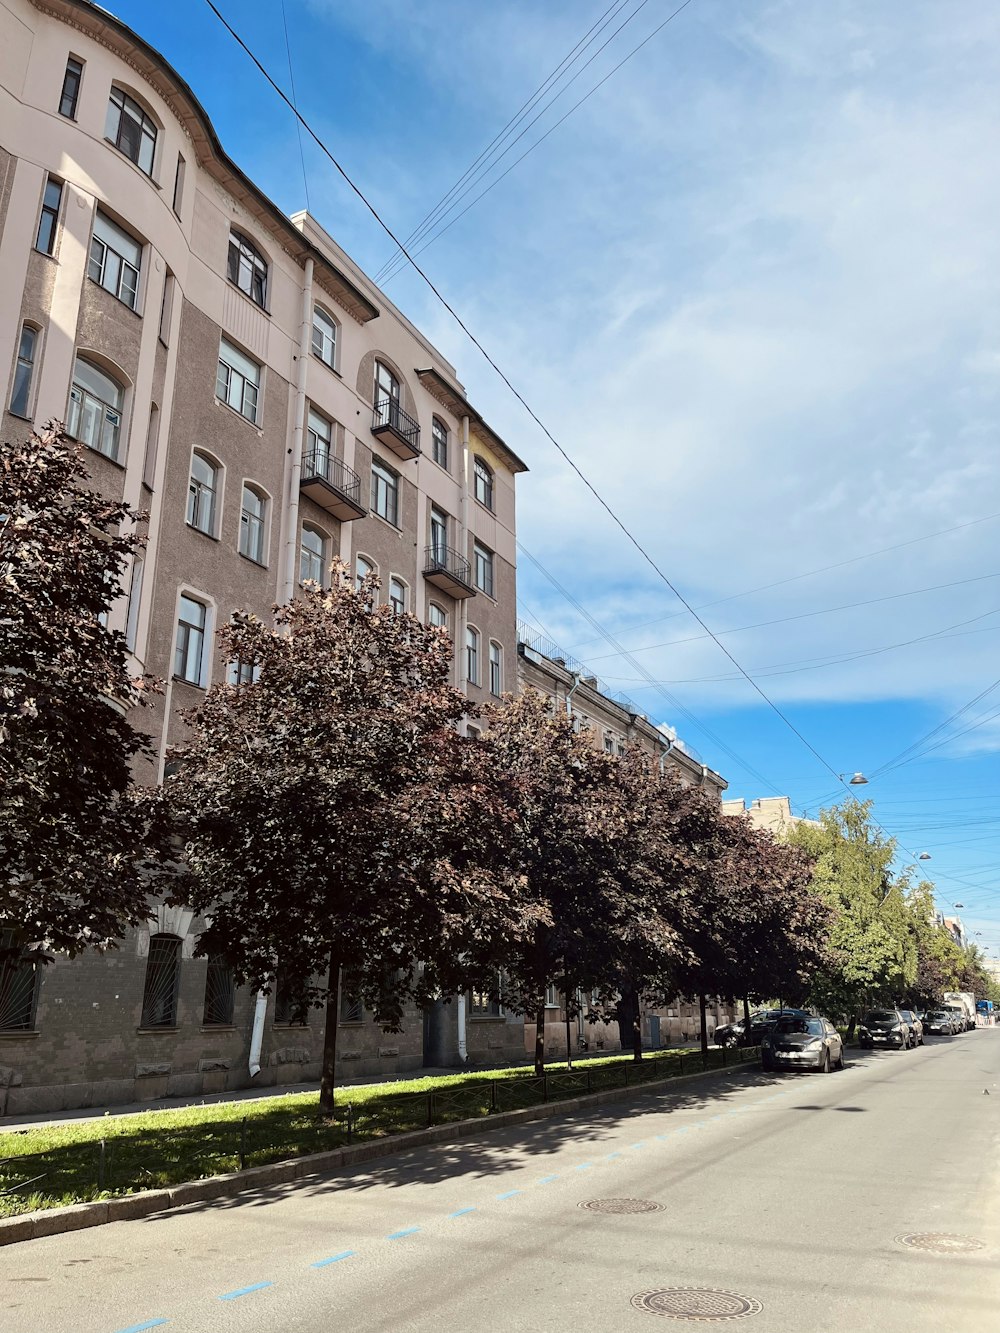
[{"xmin": 0, "ymin": 424, "xmax": 153, "ymax": 965}]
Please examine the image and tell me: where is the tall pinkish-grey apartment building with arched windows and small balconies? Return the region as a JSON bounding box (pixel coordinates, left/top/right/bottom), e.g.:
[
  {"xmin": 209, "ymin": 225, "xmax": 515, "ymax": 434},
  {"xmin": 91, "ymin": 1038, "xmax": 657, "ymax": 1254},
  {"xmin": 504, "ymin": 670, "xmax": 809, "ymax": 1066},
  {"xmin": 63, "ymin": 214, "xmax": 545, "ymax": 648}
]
[{"xmin": 0, "ymin": 0, "xmax": 525, "ymax": 1114}]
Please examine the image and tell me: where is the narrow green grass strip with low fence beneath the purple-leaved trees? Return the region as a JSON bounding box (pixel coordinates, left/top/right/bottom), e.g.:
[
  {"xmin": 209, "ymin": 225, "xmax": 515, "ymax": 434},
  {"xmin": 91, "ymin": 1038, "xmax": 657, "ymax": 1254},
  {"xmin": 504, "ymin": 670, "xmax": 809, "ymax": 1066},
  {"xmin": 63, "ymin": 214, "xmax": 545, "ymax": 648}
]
[{"xmin": 0, "ymin": 1046, "xmax": 759, "ymax": 1217}]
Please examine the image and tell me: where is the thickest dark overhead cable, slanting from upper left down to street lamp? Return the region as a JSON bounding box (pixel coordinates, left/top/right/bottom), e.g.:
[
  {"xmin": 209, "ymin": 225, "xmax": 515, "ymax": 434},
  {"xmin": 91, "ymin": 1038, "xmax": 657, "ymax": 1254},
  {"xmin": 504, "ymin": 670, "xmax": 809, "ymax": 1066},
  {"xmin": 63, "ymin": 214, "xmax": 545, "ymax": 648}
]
[{"xmin": 205, "ymin": 0, "xmax": 938, "ymax": 856}]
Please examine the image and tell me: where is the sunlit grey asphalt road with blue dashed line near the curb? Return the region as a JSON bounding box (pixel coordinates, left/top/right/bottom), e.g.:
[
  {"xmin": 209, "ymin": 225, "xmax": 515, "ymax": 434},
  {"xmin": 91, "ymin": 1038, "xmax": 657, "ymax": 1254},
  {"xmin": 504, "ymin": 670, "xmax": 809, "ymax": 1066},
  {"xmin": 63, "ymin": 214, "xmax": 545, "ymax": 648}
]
[{"xmin": 0, "ymin": 1029, "xmax": 1000, "ymax": 1333}]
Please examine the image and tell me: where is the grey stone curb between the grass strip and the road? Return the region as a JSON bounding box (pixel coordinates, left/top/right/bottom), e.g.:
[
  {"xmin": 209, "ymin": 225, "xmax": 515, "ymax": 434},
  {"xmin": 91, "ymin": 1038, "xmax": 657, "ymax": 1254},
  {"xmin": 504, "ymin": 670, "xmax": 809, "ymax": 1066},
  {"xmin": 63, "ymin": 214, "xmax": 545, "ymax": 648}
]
[{"xmin": 0, "ymin": 1061, "xmax": 757, "ymax": 1246}]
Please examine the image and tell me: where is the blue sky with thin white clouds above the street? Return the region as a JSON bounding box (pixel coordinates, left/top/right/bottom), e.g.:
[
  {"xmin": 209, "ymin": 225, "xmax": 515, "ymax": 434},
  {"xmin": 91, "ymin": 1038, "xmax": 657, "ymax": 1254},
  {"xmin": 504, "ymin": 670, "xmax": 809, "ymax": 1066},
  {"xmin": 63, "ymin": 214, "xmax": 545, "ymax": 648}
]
[{"xmin": 102, "ymin": 0, "xmax": 1000, "ymax": 952}]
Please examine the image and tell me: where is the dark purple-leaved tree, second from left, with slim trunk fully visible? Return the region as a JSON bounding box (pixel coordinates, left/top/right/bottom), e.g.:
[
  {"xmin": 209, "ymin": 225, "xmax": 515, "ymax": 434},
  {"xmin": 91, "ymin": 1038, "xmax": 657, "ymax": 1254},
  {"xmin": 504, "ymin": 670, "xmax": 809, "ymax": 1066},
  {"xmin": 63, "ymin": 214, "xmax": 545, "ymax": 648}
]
[{"xmin": 160, "ymin": 563, "xmax": 520, "ymax": 1114}]
